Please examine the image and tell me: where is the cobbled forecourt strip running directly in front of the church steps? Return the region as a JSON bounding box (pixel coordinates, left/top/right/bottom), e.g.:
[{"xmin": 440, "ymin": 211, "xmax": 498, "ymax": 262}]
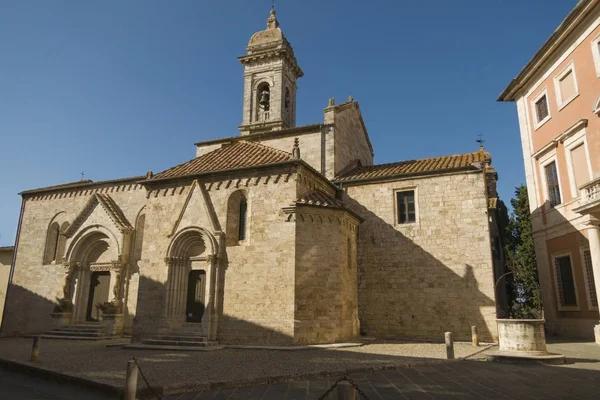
[{"xmin": 0, "ymin": 338, "xmax": 480, "ymax": 390}]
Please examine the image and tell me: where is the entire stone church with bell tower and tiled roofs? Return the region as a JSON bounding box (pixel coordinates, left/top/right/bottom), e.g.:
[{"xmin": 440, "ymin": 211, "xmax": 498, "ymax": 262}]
[{"xmin": 1, "ymin": 10, "xmax": 501, "ymax": 345}]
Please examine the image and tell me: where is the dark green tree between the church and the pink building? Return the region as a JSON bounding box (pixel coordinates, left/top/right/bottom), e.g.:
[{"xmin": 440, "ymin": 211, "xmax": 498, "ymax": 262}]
[{"xmin": 503, "ymin": 185, "xmax": 542, "ymax": 318}]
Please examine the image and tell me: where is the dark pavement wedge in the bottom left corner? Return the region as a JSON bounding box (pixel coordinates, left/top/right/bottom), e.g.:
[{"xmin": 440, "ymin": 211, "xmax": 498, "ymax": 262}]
[{"xmin": 0, "ymin": 369, "xmax": 114, "ymax": 400}]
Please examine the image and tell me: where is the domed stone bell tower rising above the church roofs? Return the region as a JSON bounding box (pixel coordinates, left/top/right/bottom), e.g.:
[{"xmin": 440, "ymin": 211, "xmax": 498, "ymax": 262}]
[{"xmin": 238, "ymin": 9, "xmax": 304, "ymax": 135}]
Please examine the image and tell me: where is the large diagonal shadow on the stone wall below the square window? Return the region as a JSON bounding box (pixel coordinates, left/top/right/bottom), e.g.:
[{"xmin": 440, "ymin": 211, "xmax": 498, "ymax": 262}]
[{"xmin": 344, "ymin": 195, "xmax": 497, "ymax": 341}]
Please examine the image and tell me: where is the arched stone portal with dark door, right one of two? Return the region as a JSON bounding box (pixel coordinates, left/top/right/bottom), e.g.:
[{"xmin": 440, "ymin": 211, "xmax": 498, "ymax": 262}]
[{"xmin": 165, "ymin": 227, "xmax": 217, "ymax": 336}]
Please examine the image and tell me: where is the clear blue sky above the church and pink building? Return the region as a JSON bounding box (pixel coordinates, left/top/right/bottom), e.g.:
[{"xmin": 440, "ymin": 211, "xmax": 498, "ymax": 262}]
[{"xmin": 0, "ymin": 0, "xmax": 576, "ymax": 245}]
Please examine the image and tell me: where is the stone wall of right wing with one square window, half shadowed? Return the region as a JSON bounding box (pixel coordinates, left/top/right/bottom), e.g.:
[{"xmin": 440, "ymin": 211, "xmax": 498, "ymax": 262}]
[{"xmin": 345, "ymin": 172, "xmax": 497, "ymax": 340}]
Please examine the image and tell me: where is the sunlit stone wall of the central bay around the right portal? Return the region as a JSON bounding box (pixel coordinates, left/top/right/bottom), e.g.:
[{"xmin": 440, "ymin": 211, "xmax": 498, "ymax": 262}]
[{"xmin": 134, "ymin": 169, "xmax": 296, "ymax": 344}]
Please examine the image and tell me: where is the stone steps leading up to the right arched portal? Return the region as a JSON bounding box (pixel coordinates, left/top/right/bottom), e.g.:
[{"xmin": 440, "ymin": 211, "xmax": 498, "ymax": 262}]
[{"xmin": 124, "ymin": 327, "xmax": 221, "ymax": 351}]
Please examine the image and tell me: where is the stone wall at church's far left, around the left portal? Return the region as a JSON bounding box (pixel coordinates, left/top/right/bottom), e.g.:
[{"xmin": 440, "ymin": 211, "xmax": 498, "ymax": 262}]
[{"xmin": 2, "ymin": 182, "xmax": 146, "ymax": 335}]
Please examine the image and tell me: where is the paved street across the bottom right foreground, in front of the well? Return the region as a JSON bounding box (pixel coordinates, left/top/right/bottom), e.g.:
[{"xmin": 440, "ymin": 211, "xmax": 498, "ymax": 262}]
[{"xmin": 165, "ymin": 343, "xmax": 600, "ymax": 400}]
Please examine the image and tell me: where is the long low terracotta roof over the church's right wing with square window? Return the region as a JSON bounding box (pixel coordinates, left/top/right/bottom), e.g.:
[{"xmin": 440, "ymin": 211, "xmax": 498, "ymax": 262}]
[{"xmin": 335, "ymin": 151, "xmax": 491, "ymax": 182}]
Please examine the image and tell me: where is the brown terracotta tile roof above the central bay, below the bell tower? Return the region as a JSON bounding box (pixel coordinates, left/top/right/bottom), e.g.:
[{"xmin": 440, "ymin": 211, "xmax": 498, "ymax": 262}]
[{"xmin": 152, "ymin": 141, "xmax": 292, "ymax": 179}]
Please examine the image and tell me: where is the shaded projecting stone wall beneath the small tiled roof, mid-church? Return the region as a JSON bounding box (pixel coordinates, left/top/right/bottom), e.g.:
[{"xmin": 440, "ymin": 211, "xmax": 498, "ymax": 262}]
[{"xmin": 294, "ymin": 206, "xmax": 359, "ymax": 344}]
